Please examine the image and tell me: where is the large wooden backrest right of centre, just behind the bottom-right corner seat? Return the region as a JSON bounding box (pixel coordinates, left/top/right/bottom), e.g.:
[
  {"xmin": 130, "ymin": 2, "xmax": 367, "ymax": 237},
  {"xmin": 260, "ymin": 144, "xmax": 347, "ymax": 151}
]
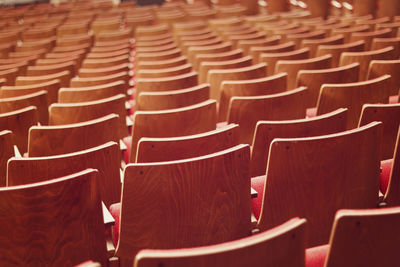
[{"xmin": 258, "ymin": 122, "xmax": 382, "ymax": 247}]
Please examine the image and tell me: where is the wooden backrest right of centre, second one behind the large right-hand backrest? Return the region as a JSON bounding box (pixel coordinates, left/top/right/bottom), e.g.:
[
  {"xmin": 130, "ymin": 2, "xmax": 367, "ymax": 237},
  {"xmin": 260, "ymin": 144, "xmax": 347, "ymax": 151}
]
[{"xmin": 228, "ymin": 87, "xmax": 307, "ymax": 144}]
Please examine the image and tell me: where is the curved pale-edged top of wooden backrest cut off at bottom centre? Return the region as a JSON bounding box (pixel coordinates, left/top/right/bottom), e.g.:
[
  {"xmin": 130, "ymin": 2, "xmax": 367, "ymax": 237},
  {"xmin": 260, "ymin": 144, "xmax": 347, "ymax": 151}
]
[{"xmin": 134, "ymin": 218, "xmax": 306, "ymax": 267}]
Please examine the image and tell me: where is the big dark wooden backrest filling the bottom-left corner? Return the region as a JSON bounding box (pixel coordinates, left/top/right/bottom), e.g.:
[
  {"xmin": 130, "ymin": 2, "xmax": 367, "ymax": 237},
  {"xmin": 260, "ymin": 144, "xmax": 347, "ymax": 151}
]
[{"xmin": 0, "ymin": 169, "xmax": 106, "ymax": 266}]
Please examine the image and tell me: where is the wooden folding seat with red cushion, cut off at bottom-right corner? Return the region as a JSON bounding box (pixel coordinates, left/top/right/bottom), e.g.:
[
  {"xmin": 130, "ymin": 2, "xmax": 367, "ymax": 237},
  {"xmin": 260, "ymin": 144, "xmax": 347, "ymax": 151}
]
[{"xmin": 306, "ymin": 207, "xmax": 400, "ymax": 267}]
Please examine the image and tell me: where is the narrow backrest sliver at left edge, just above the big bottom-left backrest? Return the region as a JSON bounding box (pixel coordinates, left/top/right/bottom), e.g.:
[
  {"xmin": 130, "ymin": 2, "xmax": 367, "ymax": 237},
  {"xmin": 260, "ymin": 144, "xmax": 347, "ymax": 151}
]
[{"xmin": 0, "ymin": 130, "xmax": 14, "ymax": 188}]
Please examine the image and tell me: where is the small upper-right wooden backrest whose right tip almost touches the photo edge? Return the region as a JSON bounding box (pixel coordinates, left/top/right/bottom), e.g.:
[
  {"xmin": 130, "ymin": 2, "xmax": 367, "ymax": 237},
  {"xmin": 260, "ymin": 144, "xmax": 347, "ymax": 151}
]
[{"xmin": 339, "ymin": 46, "xmax": 395, "ymax": 81}]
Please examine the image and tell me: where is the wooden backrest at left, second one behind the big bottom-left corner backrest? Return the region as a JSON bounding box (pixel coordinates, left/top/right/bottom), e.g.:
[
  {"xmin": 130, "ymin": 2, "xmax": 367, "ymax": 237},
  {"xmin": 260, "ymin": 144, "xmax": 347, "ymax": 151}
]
[{"xmin": 28, "ymin": 114, "xmax": 119, "ymax": 157}]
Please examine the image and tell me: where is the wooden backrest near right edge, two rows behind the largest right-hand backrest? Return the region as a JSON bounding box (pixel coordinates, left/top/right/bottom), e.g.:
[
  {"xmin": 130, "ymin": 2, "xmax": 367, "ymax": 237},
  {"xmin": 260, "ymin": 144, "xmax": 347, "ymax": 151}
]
[{"xmin": 317, "ymin": 75, "xmax": 391, "ymax": 129}]
